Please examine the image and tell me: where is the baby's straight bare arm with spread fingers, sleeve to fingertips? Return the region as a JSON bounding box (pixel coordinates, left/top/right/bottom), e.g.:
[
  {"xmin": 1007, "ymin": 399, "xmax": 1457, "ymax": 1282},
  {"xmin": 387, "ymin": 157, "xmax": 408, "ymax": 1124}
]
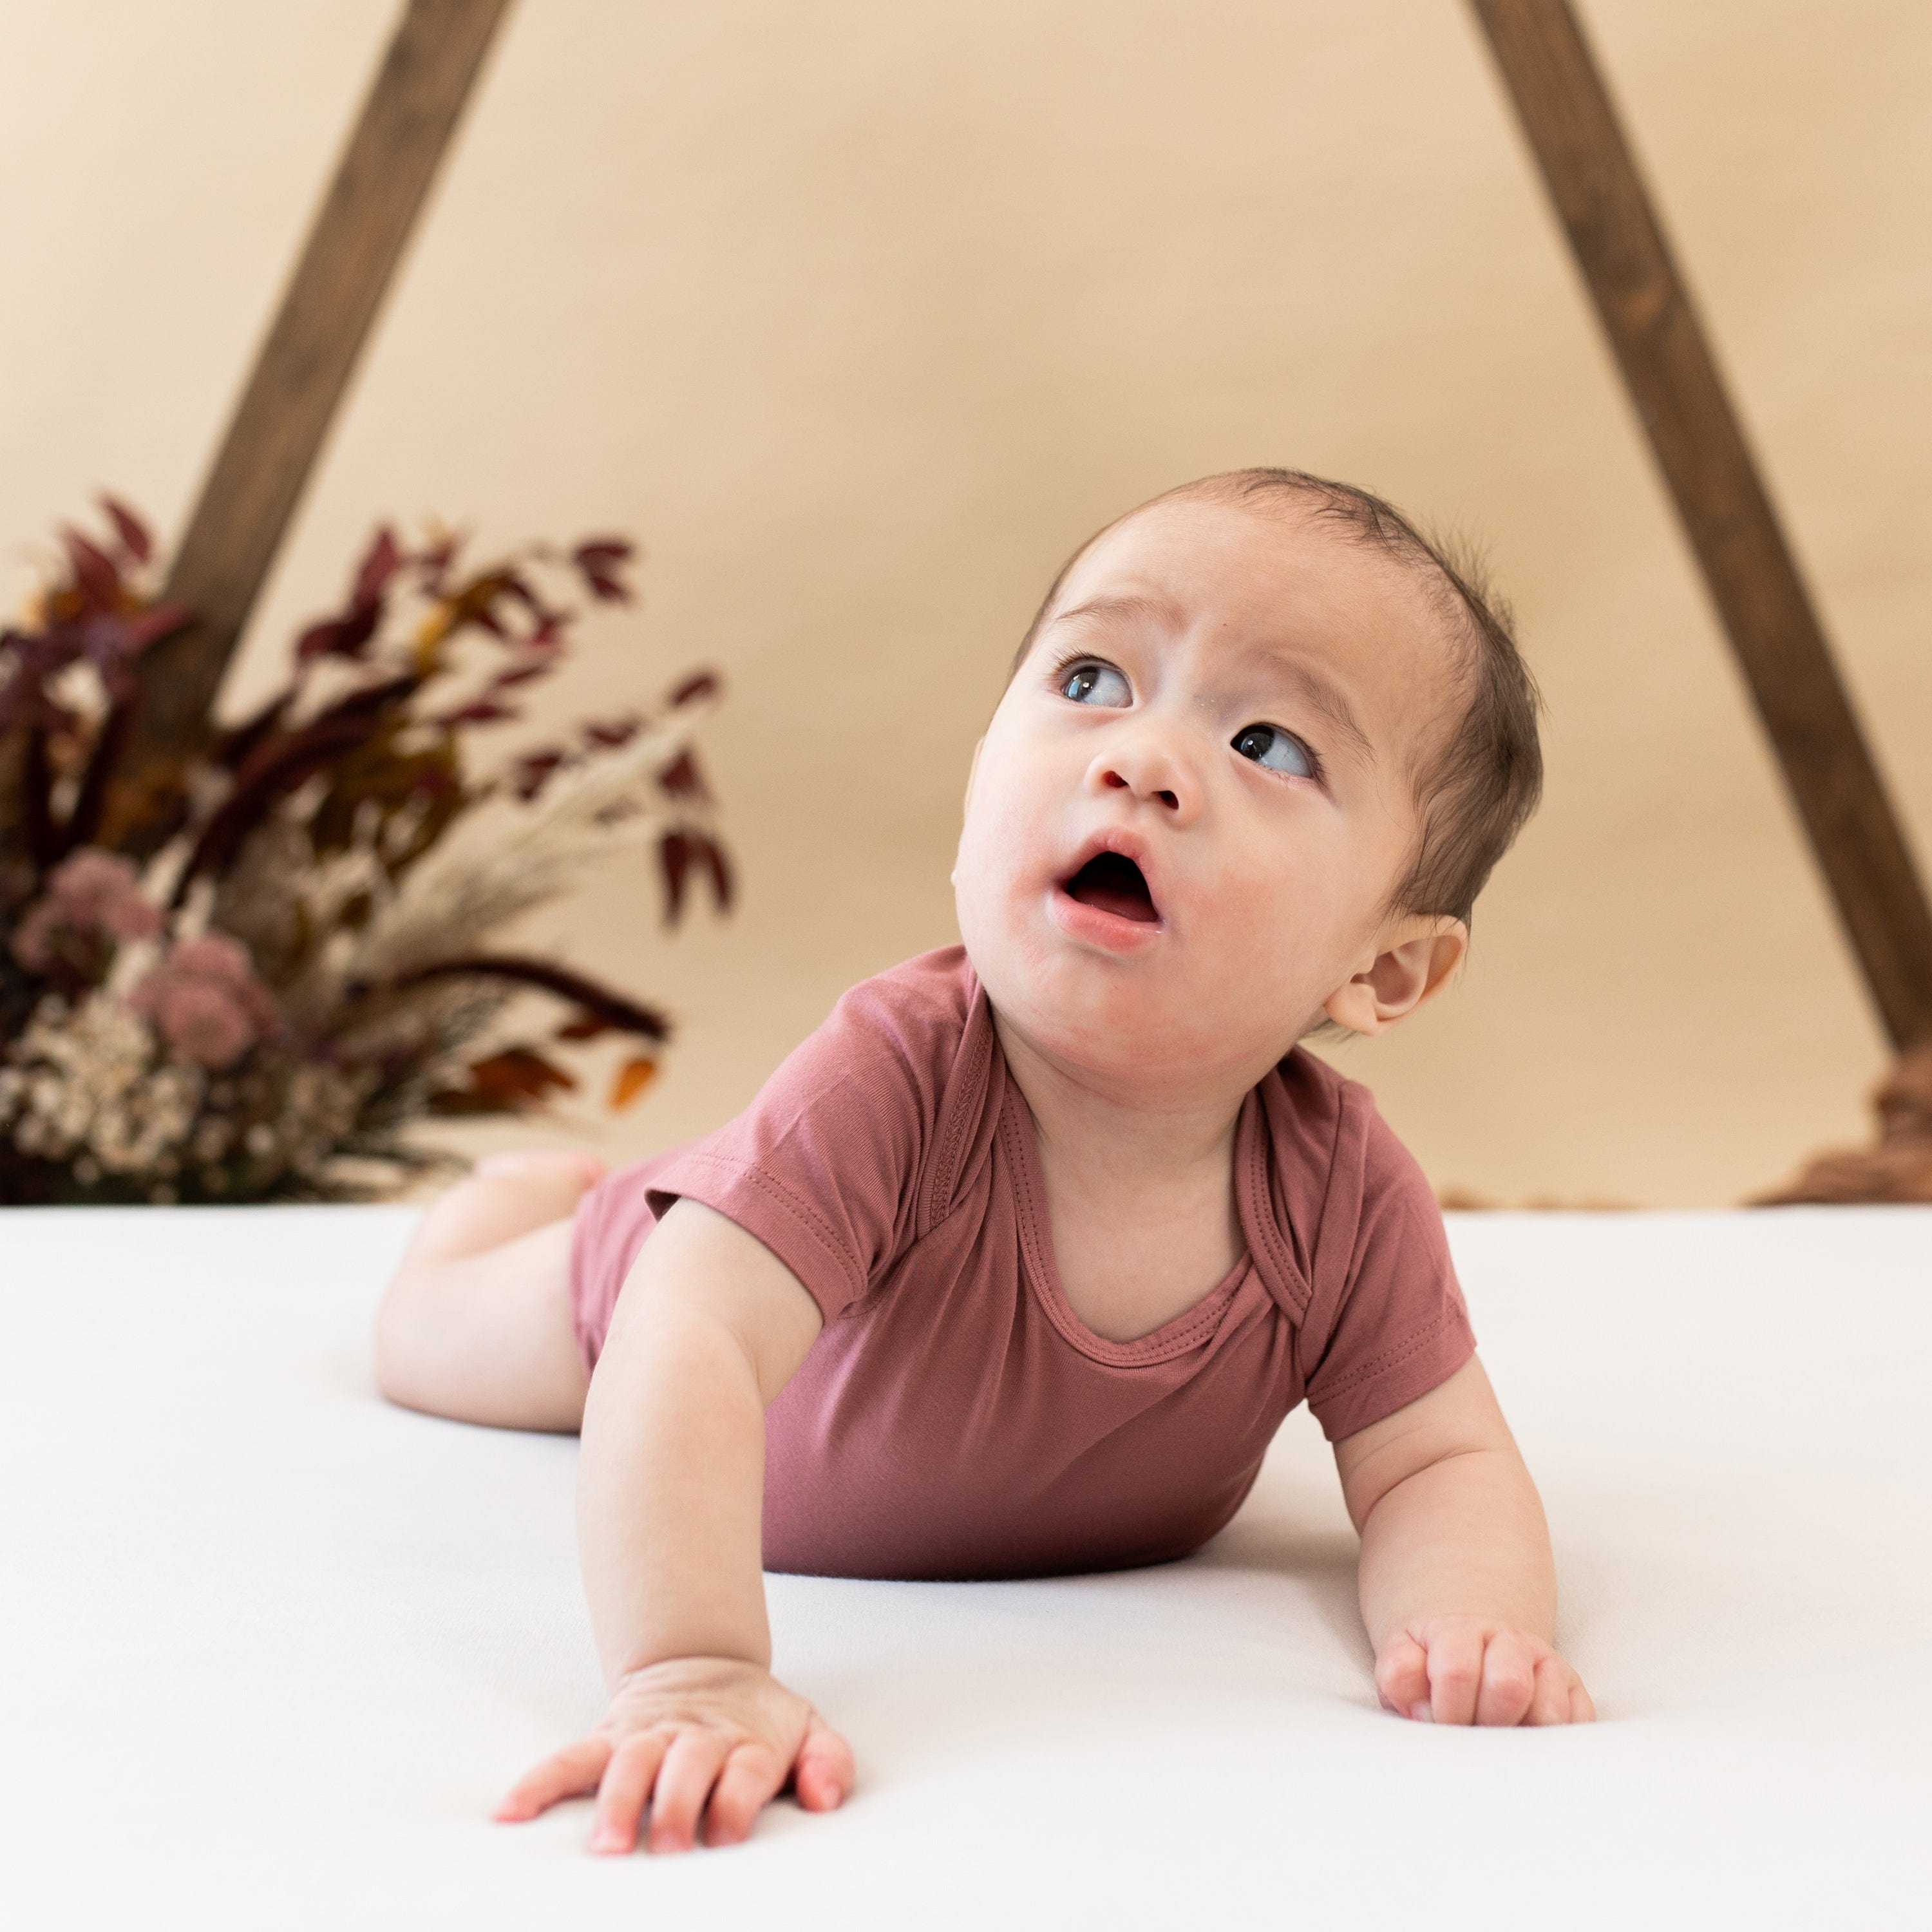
[{"xmin": 497, "ymin": 1200, "xmax": 852, "ymax": 1851}]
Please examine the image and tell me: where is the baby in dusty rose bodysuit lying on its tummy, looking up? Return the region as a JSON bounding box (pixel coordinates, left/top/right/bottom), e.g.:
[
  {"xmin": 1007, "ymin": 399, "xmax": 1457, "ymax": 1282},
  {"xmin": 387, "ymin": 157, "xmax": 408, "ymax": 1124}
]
[{"xmin": 375, "ymin": 469, "xmax": 1594, "ymax": 1851}]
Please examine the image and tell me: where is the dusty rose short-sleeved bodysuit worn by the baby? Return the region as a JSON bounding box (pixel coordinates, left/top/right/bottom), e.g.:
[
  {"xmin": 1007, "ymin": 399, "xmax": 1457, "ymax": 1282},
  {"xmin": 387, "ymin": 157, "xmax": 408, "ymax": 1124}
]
[{"xmin": 572, "ymin": 947, "xmax": 1474, "ymax": 1578}]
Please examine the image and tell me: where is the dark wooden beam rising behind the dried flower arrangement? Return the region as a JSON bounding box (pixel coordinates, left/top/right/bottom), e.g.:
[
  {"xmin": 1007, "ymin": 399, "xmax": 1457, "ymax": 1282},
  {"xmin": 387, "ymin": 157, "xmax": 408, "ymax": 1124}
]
[{"xmin": 124, "ymin": 0, "xmax": 510, "ymax": 781}]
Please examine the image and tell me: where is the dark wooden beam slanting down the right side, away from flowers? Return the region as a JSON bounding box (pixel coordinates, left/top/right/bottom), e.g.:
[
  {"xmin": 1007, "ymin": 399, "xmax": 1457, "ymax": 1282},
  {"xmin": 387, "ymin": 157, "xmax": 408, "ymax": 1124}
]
[{"xmin": 1470, "ymin": 0, "xmax": 1932, "ymax": 1047}]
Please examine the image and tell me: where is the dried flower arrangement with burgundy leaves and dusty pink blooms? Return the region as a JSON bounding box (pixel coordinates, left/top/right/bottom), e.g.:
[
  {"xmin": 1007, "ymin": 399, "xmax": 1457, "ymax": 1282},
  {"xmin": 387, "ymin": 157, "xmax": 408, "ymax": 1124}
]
[{"xmin": 0, "ymin": 498, "xmax": 732, "ymax": 1204}]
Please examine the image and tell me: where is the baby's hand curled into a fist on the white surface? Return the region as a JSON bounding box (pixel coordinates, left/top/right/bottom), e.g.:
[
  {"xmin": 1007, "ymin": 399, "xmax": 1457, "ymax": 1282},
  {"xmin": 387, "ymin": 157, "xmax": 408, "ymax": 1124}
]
[{"xmin": 1376, "ymin": 1615, "xmax": 1596, "ymax": 1723}]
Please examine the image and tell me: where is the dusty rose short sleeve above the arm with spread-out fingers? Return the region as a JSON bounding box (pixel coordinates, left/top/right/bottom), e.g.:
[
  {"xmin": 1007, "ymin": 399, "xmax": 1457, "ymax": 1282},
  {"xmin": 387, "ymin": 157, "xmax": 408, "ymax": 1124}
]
[{"xmin": 649, "ymin": 962, "xmax": 962, "ymax": 1321}]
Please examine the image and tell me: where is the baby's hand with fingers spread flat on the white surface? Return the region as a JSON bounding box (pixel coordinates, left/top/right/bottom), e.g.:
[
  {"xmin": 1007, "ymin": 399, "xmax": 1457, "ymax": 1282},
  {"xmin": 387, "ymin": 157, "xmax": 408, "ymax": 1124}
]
[{"xmin": 497, "ymin": 1658, "xmax": 852, "ymax": 1851}]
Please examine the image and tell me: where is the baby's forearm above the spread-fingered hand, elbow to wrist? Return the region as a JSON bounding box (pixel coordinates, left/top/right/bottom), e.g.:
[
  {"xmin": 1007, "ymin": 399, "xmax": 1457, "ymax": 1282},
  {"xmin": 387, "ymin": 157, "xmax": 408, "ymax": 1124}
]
[{"xmin": 578, "ymin": 1294, "xmax": 771, "ymax": 1683}]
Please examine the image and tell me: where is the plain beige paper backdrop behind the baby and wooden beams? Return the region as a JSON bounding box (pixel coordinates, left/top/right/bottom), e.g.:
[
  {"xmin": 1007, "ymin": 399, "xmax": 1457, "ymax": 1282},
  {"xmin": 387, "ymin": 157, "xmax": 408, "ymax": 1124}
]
[{"xmin": 0, "ymin": 0, "xmax": 1932, "ymax": 1204}]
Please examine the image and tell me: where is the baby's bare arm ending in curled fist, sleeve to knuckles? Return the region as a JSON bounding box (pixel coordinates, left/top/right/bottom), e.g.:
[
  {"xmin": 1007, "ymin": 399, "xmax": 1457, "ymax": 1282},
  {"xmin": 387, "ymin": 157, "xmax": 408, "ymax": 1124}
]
[{"xmin": 1335, "ymin": 1356, "xmax": 1596, "ymax": 1723}]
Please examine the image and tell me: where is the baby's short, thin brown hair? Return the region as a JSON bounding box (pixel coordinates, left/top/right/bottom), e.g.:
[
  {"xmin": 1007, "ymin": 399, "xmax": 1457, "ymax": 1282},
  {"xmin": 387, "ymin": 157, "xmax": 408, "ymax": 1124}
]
[{"xmin": 1012, "ymin": 469, "xmax": 1544, "ymax": 923}]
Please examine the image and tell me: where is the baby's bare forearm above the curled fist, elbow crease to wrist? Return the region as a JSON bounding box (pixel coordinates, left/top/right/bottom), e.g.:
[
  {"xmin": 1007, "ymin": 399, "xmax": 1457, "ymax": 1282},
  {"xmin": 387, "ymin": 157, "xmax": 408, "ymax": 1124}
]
[{"xmin": 1360, "ymin": 1447, "xmax": 1557, "ymax": 1654}]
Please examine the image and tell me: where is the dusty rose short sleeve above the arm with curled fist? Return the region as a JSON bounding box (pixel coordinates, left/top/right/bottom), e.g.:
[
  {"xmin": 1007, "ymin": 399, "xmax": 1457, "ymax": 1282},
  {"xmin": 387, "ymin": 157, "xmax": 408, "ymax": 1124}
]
[{"xmin": 1308, "ymin": 1088, "xmax": 1476, "ymax": 1441}]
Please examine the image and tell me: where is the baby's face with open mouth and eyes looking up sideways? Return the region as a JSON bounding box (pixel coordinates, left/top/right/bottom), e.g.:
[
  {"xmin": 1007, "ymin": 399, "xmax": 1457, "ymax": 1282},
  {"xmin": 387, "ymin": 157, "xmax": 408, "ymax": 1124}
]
[{"xmin": 952, "ymin": 498, "xmax": 1459, "ymax": 1086}]
